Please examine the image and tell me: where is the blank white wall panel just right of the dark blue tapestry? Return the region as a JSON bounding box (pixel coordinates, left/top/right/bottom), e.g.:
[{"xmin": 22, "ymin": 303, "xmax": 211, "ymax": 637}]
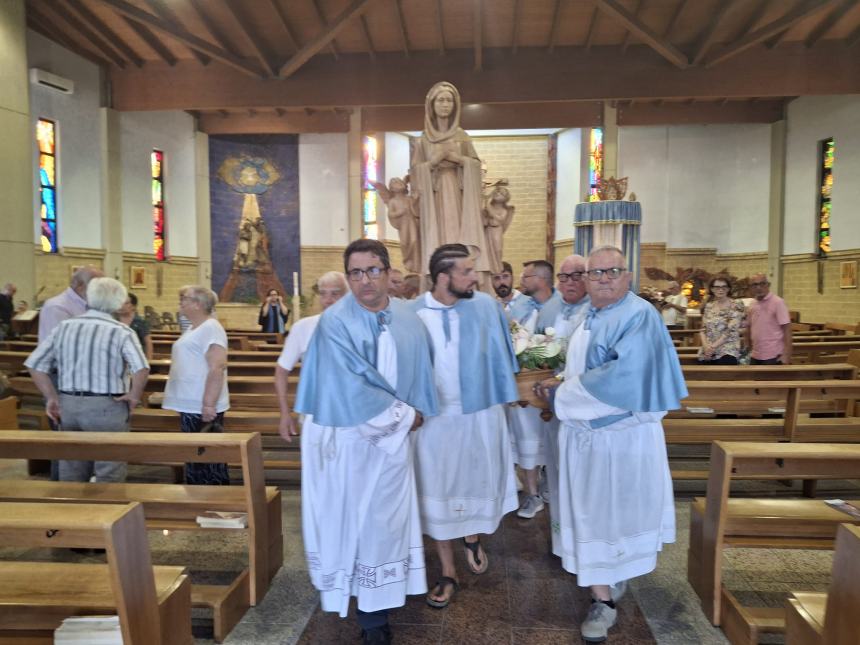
[{"xmin": 299, "ymin": 134, "xmax": 349, "ymax": 246}]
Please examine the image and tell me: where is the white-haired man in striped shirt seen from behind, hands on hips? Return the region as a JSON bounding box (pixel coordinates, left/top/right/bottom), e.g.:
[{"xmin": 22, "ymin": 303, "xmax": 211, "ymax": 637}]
[{"xmin": 24, "ymin": 278, "xmax": 149, "ymax": 482}]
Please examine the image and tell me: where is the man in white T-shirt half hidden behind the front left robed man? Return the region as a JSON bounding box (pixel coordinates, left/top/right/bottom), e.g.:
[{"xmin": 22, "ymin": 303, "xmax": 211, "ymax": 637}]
[{"xmin": 275, "ymin": 271, "xmax": 349, "ymax": 442}]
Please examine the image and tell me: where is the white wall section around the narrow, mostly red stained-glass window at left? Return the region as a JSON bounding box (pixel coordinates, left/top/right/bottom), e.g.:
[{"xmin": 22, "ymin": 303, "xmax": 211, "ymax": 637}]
[{"xmin": 120, "ymin": 111, "xmax": 197, "ymax": 257}]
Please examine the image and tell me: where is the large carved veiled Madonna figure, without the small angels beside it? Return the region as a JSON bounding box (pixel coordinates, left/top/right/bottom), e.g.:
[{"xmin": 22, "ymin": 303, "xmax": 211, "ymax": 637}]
[{"xmin": 409, "ymin": 81, "xmax": 502, "ymax": 276}]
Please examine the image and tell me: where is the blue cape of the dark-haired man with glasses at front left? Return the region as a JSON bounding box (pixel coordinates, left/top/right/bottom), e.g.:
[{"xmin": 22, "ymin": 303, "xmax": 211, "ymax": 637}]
[{"xmin": 295, "ymin": 293, "xmax": 438, "ymax": 427}]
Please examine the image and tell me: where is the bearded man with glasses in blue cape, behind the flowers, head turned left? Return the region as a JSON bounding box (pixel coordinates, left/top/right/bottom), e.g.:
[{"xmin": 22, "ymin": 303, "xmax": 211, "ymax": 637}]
[{"xmin": 508, "ymin": 260, "xmax": 561, "ymax": 519}]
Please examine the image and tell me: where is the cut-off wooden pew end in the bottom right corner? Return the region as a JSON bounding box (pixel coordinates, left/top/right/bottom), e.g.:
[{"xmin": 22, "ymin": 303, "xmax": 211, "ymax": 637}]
[{"xmin": 785, "ymin": 524, "xmax": 860, "ymax": 645}]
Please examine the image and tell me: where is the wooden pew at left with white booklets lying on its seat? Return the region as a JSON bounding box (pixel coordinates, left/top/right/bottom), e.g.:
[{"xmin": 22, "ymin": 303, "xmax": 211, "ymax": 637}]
[{"xmin": 0, "ymin": 430, "xmax": 283, "ymax": 641}]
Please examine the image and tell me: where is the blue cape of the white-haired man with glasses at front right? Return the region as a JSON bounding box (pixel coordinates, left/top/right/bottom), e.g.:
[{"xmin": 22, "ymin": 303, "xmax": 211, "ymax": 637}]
[{"xmin": 580, "ymin": 292, "xmax": 687, "ymax": 412}]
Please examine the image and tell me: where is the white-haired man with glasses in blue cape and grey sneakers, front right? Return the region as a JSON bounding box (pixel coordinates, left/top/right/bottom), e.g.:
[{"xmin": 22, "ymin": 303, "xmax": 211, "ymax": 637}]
[{"xmin": 535, "ymin": 246, "xmax": 687, "ymax": 642}]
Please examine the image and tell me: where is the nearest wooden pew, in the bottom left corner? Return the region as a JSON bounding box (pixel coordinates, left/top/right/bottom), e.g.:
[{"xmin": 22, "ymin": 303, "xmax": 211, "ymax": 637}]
[{"xmin": 0, "ymin": 503, "xmax": 193, "ymax": 645}]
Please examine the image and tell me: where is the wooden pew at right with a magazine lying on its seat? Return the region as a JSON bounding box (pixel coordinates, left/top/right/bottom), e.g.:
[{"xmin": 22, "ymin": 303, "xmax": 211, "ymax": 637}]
[{"xmin": 687, "ymin": 441, "xmax": 860, "ymax": 644}]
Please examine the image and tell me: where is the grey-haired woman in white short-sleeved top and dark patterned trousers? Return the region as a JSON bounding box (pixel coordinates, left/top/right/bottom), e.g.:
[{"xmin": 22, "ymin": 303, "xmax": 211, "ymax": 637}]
[{"xmin": 161, "ymin": 285, "xmax": 230, "ymax": 485}]
